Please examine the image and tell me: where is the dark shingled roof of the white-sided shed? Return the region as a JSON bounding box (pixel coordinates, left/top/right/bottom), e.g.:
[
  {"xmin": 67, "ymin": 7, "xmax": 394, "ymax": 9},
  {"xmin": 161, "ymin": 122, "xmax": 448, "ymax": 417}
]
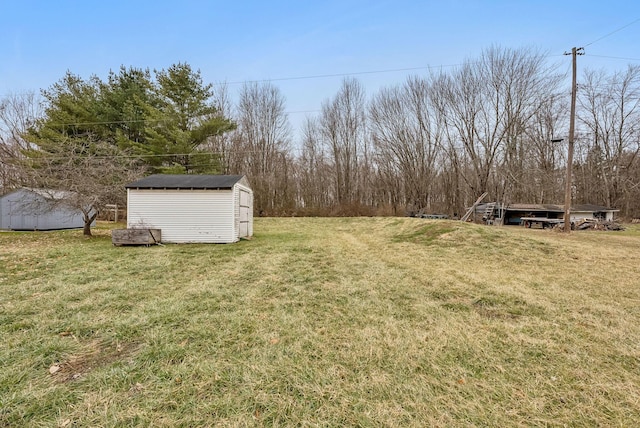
[{"xmin": 124, "ymin": 174, "xmax": 244, "ymax": 190}]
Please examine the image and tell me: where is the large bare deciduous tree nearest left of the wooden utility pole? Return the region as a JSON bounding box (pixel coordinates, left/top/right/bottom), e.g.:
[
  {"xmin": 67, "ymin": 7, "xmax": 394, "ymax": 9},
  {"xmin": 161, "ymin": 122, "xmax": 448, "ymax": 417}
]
[{"xmin": 434, "ymin": 47, "xmax": 560, "ymax": 211}]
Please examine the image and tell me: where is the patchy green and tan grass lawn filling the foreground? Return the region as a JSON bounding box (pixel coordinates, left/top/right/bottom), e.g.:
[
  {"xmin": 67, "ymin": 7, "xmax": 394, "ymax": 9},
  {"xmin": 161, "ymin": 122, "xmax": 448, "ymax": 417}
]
[{"xmin": 0, "ymin": 218, "xmax": 640, "ymax": 427}]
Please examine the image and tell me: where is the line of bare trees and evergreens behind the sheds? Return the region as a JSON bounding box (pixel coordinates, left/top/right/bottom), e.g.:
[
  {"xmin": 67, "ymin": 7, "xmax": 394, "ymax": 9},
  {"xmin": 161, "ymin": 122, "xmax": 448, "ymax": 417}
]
[{"xmin": 0, "ymin": 47, "xmax": 640, "ymax": 234}]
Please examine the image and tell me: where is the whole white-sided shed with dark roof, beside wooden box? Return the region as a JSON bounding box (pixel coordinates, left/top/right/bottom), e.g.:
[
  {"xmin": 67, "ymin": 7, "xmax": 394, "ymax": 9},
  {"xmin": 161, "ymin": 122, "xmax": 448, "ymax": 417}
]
[{"xmin": 125, "ymin": 174, "xmax": 253, "ymax": 244}]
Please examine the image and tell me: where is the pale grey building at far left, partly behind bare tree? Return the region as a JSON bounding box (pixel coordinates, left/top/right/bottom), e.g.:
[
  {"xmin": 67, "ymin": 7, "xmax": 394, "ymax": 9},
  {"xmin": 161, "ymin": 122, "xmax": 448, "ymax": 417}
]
[{"xmin": 0, "ymin": 188, "xmax": 84, "ymax": 230}]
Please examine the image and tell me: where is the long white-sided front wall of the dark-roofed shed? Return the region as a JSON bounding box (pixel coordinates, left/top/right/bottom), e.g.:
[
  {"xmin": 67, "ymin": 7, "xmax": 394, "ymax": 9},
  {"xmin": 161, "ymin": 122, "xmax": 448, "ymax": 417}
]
[{"xmin": 127, "ymin": 189, "xmax": 238, "ymax": 243}]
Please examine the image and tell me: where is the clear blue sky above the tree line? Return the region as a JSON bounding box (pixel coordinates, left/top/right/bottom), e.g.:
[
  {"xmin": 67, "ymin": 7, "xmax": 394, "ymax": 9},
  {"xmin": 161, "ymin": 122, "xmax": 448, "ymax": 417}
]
[{"xmin": 0, "ymin": 0, "xmax": 640, "ymax": 136}]
